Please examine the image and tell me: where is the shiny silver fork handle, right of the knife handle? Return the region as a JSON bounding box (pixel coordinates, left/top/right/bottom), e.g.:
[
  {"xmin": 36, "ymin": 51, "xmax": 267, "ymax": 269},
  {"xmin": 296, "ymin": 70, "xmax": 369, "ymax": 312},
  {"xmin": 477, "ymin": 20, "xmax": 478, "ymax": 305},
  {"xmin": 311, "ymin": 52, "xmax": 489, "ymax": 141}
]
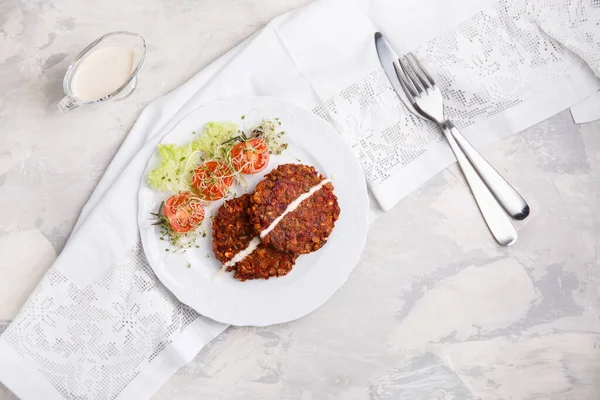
[{"xmin": 444, "ymin": 121, "xmax": 529, "ymax": 220}]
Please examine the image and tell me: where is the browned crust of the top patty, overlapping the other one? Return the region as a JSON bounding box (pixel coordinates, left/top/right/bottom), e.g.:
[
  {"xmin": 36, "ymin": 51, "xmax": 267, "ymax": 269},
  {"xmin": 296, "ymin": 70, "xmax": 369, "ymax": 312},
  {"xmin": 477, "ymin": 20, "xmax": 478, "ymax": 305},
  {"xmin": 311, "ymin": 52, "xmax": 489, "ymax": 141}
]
[{"xmin": 250, "ymin": 164, "xmax": 340, "ymax": 254}]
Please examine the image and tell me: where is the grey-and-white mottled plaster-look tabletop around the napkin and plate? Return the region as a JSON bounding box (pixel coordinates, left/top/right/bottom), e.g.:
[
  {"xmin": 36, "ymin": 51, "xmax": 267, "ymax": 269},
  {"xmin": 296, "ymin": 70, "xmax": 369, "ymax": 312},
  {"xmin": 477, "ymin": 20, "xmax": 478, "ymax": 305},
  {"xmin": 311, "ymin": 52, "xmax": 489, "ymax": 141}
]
[{"xmin": 0, "ymin": 0, "xmax": 600, "ymax": 400}]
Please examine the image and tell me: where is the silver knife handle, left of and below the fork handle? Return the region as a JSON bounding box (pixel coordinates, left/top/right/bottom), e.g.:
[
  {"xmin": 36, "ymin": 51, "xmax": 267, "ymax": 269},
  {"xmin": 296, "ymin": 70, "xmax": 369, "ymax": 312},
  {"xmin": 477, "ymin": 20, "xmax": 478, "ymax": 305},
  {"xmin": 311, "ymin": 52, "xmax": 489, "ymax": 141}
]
[{"xmin": 442, "ymin": 125, "xmax": 517, "ymax": 246}]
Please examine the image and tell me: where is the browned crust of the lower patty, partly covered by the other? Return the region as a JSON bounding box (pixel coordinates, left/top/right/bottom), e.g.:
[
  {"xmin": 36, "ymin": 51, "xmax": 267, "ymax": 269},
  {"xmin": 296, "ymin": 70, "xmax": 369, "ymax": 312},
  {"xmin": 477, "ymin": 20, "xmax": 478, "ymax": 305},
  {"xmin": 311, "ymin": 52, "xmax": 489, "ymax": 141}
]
[{"xmin": 212, "ymin": 194, "xmax": 297, "ymax": 281}]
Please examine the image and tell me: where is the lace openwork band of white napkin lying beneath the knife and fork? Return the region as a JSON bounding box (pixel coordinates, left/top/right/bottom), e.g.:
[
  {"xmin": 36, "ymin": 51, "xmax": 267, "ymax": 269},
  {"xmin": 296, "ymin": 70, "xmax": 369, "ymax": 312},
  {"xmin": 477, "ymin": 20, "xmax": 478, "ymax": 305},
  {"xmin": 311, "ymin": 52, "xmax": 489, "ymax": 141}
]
[{"xmin": 313, "ymin": 0, "xmax": 598, "ymax": 187}]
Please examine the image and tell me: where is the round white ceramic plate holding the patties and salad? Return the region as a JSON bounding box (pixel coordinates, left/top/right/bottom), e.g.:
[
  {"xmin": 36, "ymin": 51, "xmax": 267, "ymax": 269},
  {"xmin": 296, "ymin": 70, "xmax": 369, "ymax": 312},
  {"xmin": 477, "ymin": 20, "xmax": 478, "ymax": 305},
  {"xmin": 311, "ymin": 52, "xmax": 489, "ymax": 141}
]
[{"xmin": 138, "ymin": 97, "xmax": 368, "ymax": 326}]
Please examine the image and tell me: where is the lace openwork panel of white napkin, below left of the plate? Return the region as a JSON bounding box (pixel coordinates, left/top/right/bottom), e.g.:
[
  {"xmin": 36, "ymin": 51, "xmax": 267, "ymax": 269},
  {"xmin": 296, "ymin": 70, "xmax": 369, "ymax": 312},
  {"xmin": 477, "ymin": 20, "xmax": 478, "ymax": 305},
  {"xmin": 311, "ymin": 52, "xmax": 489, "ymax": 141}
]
[{"xmin": 3, "ymin": 243, "xmax": 199, "ymax": 399}]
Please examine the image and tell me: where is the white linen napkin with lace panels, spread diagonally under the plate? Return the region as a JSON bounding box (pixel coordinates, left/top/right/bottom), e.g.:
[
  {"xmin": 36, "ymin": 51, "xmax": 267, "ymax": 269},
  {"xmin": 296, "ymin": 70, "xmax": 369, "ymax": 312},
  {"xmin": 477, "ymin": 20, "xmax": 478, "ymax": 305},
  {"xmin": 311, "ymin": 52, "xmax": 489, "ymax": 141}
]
[{"xmin": 0, "ymin": 0, "xmax": 600, "ymax": 399}]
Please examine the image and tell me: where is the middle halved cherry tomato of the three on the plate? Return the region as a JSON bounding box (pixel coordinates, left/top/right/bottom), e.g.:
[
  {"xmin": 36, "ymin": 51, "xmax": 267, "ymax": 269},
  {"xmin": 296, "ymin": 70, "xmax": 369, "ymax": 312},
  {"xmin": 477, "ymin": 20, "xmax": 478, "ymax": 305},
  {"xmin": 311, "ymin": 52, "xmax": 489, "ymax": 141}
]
[{"xmin": 192, "ymin": 161, "xmax": 233, "ymax": 201}]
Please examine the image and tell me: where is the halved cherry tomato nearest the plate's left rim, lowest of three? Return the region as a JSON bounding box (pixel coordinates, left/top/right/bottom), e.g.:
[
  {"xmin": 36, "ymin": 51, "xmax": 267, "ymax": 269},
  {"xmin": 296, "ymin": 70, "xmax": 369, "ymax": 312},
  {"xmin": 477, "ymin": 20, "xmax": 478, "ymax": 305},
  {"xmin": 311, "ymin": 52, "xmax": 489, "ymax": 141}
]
[{"xmin": 163, "ymin": 192, "xmax": 204, "ymax": 233}]
